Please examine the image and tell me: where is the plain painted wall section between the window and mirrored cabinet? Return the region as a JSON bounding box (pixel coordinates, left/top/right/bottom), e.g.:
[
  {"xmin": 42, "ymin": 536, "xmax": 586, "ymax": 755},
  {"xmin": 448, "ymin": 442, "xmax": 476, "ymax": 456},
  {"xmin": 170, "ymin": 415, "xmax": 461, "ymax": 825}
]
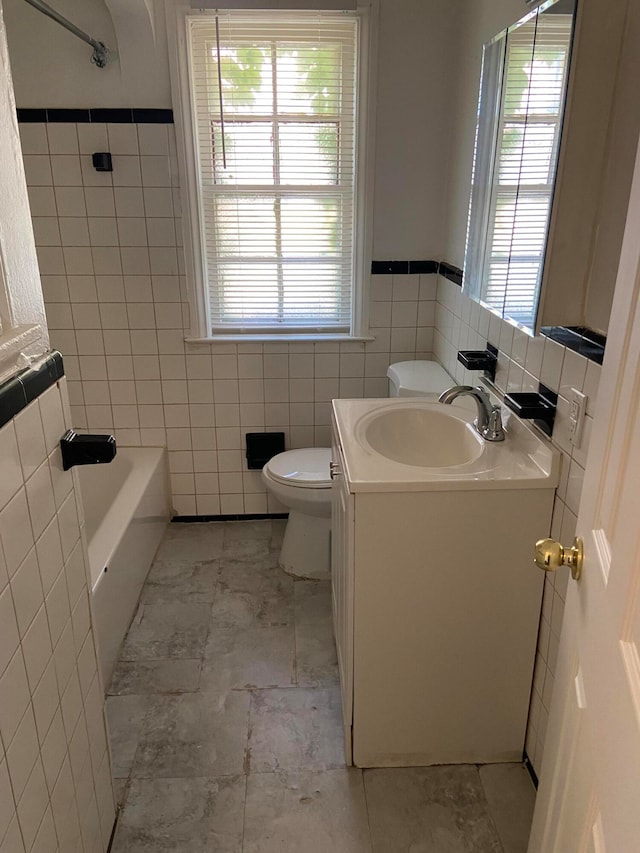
[{"xmin": 374, "ymin": 0, "xmax": 468, "ymax": 260}]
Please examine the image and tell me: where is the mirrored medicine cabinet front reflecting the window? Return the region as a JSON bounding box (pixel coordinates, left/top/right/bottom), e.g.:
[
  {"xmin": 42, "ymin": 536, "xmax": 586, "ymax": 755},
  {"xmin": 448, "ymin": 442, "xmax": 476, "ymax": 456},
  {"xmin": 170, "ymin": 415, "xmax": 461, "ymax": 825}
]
[{"xmin": 463, "ymin": 0, "xmax": 575, "ymax": 330}]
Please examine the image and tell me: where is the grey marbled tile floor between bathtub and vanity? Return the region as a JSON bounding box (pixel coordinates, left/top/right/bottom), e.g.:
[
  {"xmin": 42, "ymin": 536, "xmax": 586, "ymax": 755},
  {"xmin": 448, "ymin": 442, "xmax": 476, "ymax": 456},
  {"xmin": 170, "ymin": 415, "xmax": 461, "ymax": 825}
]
[{"xmin": 107, "ymin": 521, "xmax": 534, "ymax": 853}]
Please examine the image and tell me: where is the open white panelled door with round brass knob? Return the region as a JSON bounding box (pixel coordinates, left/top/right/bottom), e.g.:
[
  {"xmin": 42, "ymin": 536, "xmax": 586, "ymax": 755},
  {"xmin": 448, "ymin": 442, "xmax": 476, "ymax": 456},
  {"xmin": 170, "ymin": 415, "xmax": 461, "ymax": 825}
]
[{"xmin": 529, "ymin": 135, "xmax": 640, "ymax": 853}]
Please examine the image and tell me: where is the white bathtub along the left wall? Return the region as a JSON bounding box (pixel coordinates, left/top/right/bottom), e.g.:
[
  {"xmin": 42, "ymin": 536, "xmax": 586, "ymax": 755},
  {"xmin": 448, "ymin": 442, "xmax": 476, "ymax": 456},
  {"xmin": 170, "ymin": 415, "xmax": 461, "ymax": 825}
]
[{"xmin": 76, "ymin": 447, "xmax": 169, "ymax": 690}]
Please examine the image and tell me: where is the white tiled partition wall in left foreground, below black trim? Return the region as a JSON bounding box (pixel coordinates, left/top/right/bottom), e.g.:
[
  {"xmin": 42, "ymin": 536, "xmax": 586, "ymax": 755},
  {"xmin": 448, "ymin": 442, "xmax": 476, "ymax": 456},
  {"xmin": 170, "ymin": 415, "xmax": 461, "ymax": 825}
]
[{"xmin": 0, "ymin": 382, "xmax": 115, "ymax": 853}]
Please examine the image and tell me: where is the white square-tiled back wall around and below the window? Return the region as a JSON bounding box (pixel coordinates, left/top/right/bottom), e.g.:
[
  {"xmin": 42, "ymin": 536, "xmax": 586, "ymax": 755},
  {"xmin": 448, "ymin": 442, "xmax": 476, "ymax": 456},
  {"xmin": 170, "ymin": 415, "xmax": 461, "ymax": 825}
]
[{"xmin": 21, "ymin": 124, "xmax": 436, "ymax": 515}]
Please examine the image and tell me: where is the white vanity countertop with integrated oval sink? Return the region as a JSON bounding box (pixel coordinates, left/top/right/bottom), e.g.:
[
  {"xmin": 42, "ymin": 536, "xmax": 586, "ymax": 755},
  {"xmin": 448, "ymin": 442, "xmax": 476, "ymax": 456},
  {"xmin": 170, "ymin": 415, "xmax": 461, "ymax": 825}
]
[{"xmin": 333, "ymin": 397, "xmax": 559, "ymax": 492}]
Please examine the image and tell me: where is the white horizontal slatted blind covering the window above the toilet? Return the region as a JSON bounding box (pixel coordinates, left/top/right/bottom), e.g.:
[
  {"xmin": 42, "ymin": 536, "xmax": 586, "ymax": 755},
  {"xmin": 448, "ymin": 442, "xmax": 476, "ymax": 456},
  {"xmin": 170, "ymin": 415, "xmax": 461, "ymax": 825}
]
[{"xmin": 188, "ymin": 12, "xmax": 358, "ymax": 334}]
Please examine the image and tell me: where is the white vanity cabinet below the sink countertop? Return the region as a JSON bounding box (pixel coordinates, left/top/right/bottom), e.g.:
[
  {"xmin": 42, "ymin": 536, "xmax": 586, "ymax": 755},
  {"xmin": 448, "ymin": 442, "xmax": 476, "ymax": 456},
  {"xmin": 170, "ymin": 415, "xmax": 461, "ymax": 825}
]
[{"xmin": 332, "ymin": 401, "xmax": 555, "ymax": 767}]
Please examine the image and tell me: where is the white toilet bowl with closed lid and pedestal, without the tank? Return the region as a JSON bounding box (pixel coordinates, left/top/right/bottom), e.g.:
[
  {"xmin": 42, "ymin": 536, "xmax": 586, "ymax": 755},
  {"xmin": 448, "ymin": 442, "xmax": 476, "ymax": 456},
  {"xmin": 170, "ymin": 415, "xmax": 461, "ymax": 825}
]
[{"xmin": 262, "ymin": 447, "xmax": 331, "ymax": 580}]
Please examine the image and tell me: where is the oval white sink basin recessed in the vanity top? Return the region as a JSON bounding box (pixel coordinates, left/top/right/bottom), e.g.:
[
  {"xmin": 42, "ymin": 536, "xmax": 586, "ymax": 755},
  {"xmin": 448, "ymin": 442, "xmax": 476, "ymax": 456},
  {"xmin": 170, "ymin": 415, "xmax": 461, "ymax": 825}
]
[{"xmin": 358, "ymin": 405, "xmax": 484, "ymax": 468}]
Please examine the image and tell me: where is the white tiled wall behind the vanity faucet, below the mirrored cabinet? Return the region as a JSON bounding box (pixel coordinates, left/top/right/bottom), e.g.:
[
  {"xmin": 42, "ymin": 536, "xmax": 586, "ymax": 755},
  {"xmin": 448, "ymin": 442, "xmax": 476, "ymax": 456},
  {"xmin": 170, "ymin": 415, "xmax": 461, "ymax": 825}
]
[{"xmin": 433, "ymin": 278, "xmax": 601, "ymax": 773}]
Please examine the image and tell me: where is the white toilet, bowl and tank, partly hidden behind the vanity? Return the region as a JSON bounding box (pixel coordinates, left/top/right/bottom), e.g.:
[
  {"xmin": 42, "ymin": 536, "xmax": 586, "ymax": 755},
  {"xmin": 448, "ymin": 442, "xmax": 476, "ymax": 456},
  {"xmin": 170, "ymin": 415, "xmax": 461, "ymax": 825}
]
[{"xmin": 262, "ymin": 361, "xmax": 456, "ymax": 580}]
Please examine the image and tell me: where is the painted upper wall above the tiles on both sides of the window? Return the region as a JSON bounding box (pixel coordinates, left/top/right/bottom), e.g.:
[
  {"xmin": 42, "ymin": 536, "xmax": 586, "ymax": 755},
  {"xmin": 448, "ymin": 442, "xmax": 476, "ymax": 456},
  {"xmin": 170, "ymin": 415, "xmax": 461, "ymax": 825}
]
[{"xmin": 5, "ymin": 0, "xmax": 463, "ymax": 260}]
